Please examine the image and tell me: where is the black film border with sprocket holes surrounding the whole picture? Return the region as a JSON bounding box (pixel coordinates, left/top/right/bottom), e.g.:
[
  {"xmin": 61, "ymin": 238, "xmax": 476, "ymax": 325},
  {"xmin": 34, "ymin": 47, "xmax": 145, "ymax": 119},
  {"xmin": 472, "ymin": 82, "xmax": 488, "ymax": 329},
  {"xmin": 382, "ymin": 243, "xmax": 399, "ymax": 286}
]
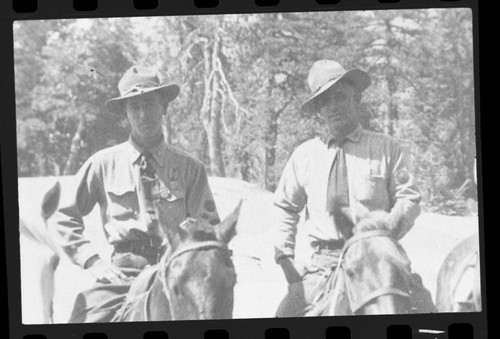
[{"xmin": 0, "ymin": 0, "xmax": 488, "ymax": 339}]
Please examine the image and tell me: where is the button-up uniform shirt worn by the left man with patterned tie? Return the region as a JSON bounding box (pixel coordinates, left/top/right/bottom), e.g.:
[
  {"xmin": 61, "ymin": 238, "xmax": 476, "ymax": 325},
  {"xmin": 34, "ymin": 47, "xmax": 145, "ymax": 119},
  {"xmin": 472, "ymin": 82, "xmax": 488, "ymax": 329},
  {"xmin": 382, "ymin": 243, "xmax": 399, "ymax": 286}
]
[{"xmin": 55, "ymin": 138, "xmax": 220, "ymax": 267}]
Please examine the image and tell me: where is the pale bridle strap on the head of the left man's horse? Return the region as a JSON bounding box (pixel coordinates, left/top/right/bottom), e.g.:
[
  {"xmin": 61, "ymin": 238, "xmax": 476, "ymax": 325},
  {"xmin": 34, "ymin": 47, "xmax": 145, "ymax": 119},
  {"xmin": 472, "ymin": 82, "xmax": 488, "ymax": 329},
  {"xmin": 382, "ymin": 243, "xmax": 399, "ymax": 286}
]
[{"xmin": 153, "ymin": 240, "xmax": 232, "ymax": 320}]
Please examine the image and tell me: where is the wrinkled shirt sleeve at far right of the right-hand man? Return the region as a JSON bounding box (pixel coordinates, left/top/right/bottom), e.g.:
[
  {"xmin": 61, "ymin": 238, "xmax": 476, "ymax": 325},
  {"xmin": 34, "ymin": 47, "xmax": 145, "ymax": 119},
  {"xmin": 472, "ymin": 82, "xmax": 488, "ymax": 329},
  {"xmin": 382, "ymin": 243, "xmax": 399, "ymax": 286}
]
[{"xmin": 389, "ymin": 145, "xmax": 421, "ymax": 239}]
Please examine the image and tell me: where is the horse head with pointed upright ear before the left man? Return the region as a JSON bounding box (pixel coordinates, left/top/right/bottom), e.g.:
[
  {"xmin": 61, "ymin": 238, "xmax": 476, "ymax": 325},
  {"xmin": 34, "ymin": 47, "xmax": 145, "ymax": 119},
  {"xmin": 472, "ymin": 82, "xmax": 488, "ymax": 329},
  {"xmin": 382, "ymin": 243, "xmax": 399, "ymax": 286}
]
[{"xmin": 158, "ymin": 201, "xmax": 241, "ymax": 319}]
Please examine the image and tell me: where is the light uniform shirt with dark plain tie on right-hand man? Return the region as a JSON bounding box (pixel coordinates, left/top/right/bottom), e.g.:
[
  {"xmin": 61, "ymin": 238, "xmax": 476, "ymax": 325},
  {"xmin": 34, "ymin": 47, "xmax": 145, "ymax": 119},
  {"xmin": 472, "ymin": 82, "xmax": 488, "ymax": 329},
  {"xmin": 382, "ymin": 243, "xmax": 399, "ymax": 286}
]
[{"xmin": 274, "ymin": 126, "xmax": 420, "ymax": 261}]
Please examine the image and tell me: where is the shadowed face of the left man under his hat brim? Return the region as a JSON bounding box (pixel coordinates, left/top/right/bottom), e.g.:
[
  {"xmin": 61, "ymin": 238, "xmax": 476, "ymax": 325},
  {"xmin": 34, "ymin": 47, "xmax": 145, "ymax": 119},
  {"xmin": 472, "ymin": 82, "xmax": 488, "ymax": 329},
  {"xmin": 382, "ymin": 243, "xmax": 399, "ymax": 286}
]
[{"xmin": 125, "ymin": 93, "xmax": 164, "ymax": 138}]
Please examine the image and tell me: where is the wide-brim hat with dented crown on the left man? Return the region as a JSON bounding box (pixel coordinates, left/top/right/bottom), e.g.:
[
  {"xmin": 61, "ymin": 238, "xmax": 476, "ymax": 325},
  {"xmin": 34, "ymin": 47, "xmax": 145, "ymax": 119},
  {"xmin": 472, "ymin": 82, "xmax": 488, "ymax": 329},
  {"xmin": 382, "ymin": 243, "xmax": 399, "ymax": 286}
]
[{"xmin": 105, "ymin": 66, "xmax": 180, "ymax": 115}]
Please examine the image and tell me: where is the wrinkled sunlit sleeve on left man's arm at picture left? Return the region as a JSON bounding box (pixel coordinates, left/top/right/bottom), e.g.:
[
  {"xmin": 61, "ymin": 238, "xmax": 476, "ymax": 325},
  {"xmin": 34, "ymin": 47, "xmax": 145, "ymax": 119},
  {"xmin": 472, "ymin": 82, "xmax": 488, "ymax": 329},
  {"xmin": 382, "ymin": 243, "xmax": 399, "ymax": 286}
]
[{"xmin": 53, "ymin": 160, "xmax": 99, "ymax": 267}]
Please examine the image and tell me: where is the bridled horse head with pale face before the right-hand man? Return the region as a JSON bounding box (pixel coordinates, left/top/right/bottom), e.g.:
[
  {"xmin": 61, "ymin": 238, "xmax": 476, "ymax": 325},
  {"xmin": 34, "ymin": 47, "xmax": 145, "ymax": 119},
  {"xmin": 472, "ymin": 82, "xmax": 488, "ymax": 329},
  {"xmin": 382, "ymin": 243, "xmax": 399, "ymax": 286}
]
[{"xmin": 329, "ymin": 206, "xmax": 411, "ymax": 314}]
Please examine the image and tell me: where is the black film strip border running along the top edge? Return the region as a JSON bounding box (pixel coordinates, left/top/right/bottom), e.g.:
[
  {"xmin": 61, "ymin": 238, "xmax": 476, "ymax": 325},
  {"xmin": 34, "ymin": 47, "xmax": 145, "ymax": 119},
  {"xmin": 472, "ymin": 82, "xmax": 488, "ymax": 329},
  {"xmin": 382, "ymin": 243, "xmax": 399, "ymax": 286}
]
[{"xmin": 6, "ymin": 0, "xmax": 476, "ymax": 18}]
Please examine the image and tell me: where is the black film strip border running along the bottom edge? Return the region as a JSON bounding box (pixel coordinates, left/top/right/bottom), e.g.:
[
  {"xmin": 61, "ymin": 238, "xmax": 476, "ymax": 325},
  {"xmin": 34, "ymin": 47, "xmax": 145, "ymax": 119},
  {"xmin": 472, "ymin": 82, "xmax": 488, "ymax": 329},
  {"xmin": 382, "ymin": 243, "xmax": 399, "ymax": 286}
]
[{"xmin": 16, "ymin": 312, "xmax": 488, "ymax": 339}]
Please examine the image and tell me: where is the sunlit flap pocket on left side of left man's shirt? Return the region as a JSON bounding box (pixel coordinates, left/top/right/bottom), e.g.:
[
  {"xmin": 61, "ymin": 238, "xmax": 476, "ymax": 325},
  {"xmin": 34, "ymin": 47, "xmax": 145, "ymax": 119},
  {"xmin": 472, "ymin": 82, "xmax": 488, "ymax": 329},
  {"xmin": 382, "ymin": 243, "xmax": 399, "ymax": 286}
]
[{"xmin": 106, "ymin": 182, "xmax": 139, "ymax": 221}]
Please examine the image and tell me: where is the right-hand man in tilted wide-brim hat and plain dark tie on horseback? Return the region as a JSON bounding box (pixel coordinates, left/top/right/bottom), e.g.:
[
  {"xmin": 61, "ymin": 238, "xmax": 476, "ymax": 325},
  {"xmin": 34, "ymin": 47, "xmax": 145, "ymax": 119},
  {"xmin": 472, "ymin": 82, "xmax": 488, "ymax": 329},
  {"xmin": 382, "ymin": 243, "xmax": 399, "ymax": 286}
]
[{"xmin": 274, "ymin": 60, "xmax": 428, "ymax": 317}]
